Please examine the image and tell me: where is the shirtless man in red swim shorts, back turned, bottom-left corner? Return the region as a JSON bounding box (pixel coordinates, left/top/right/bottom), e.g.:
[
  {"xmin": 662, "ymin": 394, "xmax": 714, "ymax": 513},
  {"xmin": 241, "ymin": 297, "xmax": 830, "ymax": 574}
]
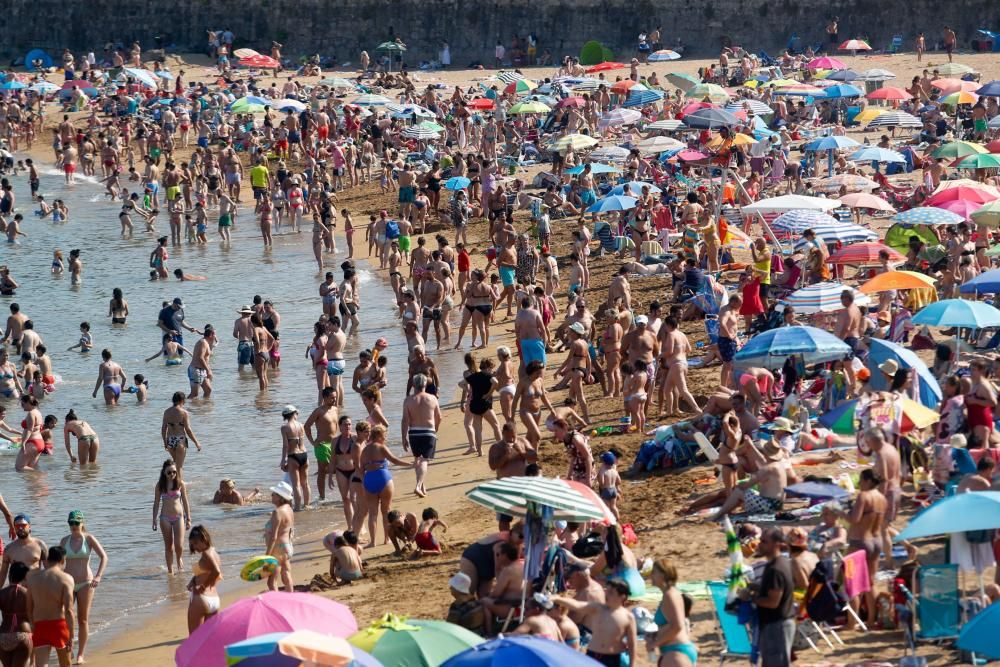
[{"xmin": 26, "ymin": 547, "xmax": 76, "ymax": 667}]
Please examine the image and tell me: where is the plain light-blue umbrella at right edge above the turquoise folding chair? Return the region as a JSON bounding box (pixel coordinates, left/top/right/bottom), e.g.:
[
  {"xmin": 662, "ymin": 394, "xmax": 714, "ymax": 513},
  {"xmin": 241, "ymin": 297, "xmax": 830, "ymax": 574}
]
[{"xmin": 892, "ymin": 491, "xmax": 1000, "ymax": 544}]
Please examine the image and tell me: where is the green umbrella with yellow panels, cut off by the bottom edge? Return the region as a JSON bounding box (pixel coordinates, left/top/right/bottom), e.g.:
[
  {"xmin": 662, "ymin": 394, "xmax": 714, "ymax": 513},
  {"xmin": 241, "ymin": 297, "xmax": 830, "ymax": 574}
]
[{"xmin": 347, "ymin": 614, "xmax": 483, "ymax": 667}]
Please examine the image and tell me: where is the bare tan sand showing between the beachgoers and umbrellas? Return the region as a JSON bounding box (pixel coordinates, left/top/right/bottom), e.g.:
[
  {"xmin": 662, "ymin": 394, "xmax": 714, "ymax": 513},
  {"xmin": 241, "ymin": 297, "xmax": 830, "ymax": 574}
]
[{"xmin": 9, "ymin": 48, "xmax": 1000, "ymax": 667}]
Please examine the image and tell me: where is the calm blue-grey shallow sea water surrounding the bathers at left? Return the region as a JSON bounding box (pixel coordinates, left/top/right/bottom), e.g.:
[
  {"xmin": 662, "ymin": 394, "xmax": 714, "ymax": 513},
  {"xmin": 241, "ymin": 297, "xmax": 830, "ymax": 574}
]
[{"xmin": 0, "ymin": 162, "xmax": 461, "ymax": 642}]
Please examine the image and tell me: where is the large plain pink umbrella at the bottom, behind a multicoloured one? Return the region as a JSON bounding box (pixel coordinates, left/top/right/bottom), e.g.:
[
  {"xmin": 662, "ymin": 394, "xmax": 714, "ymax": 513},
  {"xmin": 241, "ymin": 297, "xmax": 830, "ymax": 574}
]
[{"xmin": 175, "ymin": 591, "xmax": 358, "ymax": 667}]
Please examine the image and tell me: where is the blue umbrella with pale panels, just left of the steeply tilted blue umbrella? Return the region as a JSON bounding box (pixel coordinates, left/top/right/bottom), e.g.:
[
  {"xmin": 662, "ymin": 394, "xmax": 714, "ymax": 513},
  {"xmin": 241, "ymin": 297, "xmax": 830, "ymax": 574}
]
[{"xmin": 733, "ymin": 326, "xmax": 851, "ymax": 368}]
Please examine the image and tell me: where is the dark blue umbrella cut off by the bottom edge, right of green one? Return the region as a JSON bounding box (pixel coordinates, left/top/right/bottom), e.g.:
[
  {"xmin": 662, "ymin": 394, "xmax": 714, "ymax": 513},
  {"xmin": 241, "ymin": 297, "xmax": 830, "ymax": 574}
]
[{"xmin": 441, "ymin": 635, "xmax": 601, "ymax": 667}]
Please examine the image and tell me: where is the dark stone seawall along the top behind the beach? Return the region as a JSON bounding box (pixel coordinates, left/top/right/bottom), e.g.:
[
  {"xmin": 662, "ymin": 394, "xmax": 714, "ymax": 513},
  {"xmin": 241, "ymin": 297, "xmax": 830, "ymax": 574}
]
[{"xmin": 0, "ymin": 0, "xmax": 1000, "ymax": 67}]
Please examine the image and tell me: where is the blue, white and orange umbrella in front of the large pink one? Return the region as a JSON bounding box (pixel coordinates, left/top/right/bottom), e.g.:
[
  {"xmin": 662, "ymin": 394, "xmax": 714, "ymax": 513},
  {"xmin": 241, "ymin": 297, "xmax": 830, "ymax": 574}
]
[{"xmin": 226, "ymin": 630, "xmax": 384, "ymax": 667}]
